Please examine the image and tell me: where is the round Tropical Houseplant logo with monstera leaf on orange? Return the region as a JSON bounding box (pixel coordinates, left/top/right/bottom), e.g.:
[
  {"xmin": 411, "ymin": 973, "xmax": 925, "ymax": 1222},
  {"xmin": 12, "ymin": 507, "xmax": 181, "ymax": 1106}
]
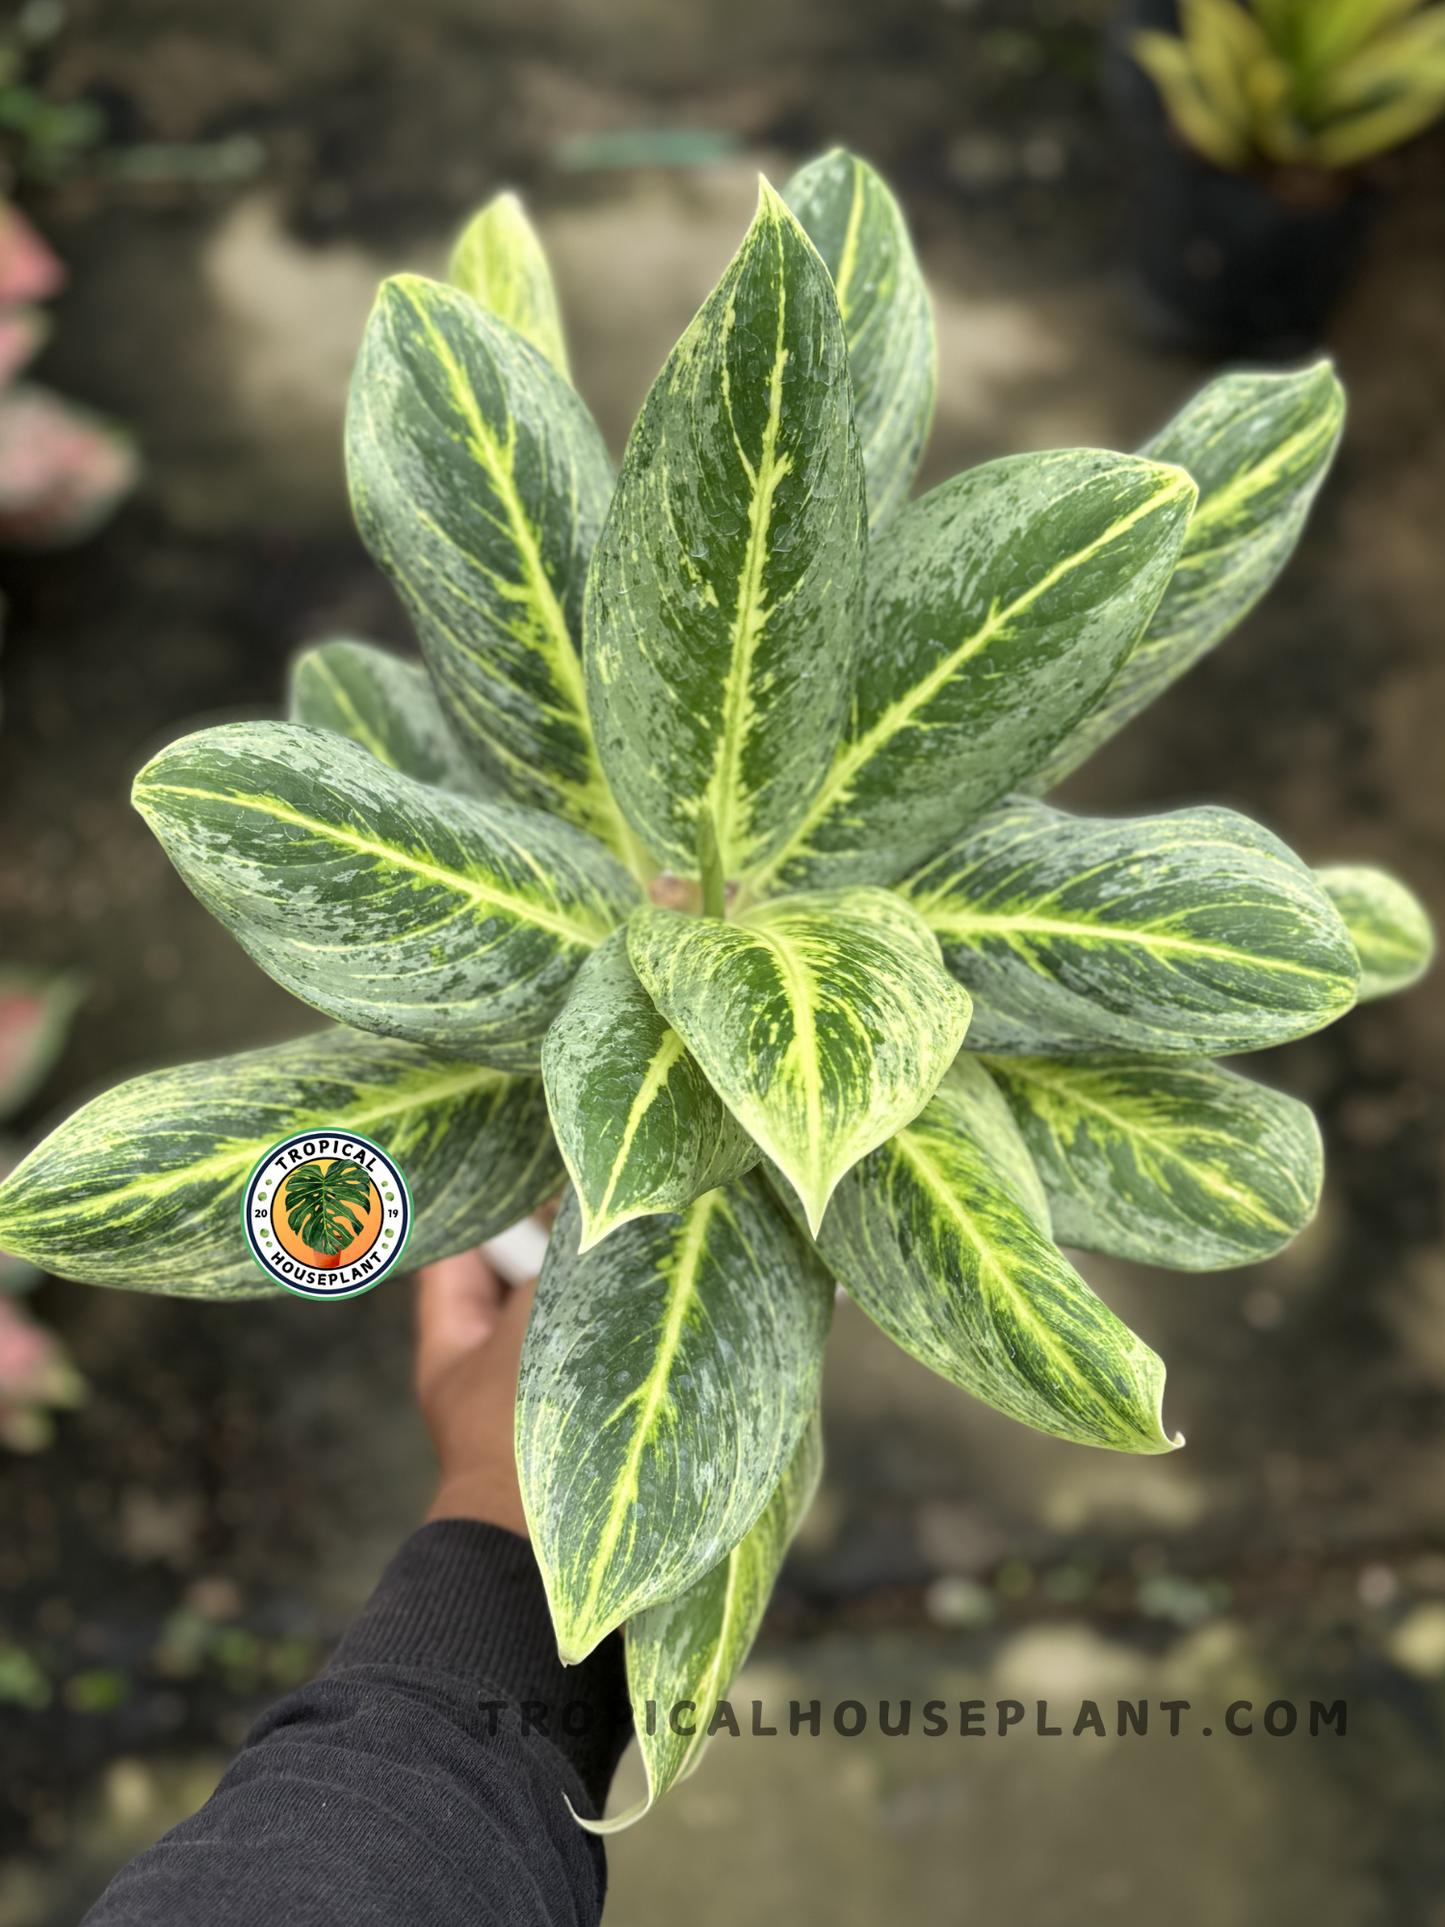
[{"xmin": 243, "ymin": 1127, "xmax": 412, "ymax": 1299}]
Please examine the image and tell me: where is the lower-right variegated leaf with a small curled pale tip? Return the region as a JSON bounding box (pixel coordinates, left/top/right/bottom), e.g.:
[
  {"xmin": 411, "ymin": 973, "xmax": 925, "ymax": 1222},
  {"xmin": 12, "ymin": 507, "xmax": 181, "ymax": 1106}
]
[{"xmin": 797, "ymin": 1050, "xmax": 1183, "ymax": 1453}]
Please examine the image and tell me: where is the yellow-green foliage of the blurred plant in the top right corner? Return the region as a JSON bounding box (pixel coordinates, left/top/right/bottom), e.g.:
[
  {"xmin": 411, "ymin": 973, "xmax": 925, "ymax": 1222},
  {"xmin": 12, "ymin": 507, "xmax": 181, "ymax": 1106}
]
[{"xmin": 1133, "ymin": 0, "xmax": 1445, "ymax": 172}]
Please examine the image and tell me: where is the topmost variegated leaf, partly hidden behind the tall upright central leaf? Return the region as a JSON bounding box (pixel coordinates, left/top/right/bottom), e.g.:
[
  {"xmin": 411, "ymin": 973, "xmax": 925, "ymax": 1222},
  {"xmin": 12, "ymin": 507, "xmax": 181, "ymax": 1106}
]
[{"xmin": 782, "ymin": 146, "xmax": 938, "ymax": 530}]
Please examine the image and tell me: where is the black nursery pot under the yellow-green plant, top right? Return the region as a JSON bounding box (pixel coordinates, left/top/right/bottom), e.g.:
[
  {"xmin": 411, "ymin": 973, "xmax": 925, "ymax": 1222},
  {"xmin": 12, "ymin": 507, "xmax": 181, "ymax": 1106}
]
[{"xmin": 1104, "ymin": 0, "xmax": 1374, "ymax": 358}]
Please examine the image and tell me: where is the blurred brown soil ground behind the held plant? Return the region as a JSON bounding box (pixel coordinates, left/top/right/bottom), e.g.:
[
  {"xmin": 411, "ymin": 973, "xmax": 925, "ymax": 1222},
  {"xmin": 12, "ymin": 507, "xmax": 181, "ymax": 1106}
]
[{"xmin": 0, "ymin": 0, "xmax": 1445, "ymax": 1927}]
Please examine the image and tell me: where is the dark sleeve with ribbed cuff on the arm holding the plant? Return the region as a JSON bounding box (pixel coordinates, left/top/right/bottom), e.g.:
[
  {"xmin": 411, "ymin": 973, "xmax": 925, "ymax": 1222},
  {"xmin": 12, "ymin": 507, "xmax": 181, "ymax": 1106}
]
[{"xmin": 85, "ymin": 1518, "xmax": 632, "ymax": 1927}]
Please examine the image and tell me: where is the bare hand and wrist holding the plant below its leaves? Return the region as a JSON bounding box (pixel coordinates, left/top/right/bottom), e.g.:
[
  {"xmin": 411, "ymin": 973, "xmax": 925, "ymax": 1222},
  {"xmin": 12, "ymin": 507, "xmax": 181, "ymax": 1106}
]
[{"xmin": 416, "ymin": 1251, "xmax": 536, "ymax": 1538}]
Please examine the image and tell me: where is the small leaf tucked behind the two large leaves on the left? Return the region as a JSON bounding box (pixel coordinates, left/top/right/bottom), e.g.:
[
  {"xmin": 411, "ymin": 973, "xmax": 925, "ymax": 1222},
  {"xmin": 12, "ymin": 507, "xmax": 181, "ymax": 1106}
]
[{"xmin": 289, "ymin": 640, "xmax": 497, "ymax": 796}]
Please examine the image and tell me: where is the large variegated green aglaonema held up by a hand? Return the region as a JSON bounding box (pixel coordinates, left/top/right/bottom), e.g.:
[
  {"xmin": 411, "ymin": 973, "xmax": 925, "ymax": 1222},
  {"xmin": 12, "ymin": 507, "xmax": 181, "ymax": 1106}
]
[{"xmin": 0, "ymin": 152, "xmax": 1432, "ymax": 1800}]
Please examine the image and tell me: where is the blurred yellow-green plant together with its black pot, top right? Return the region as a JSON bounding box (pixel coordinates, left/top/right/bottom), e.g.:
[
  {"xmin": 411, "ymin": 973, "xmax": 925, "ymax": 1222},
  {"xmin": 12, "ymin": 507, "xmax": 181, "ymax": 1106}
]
[{"xmin": 1106, "ymin": 0, "xmax": 1445, "ymax": 355}]
